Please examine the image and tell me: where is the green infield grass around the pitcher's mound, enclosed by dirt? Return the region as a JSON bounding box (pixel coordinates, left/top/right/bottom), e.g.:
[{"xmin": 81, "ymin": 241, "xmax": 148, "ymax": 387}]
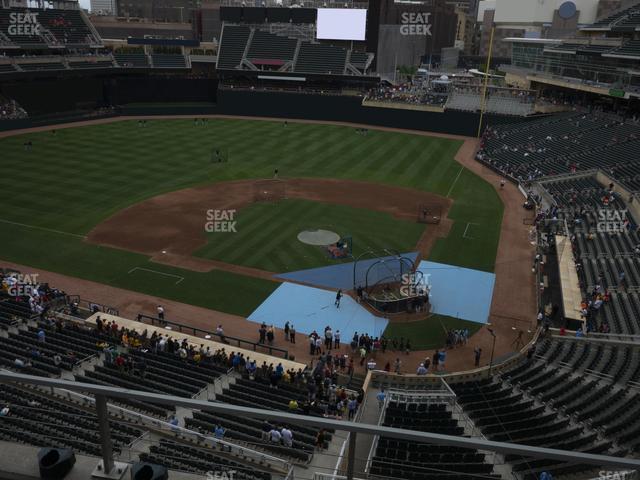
[{"xmin": 196, "ymin": 200, "xmax": 424, "ymax": 273}]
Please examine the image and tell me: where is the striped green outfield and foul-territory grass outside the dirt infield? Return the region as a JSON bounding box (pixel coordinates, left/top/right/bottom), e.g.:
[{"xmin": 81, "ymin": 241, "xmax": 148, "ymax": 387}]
[{"xmin": 0, "ymin": 120, "xmax": 502, "ymax": 315}]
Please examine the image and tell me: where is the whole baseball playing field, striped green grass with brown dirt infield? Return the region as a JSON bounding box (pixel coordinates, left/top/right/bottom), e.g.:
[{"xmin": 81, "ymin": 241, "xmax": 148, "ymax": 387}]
[{"xmin": 0, "ymin": 119, "xmax": 503, "ymax": 316}]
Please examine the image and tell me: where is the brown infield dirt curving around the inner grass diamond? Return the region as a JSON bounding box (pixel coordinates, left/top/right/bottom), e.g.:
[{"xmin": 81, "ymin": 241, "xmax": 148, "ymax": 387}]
[{"xmin": 87, "ymin": 178, "xmax": 452, "ymax": 279}]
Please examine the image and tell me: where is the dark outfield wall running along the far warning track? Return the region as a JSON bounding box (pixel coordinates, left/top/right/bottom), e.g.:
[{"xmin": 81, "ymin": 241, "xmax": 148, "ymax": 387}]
[{"xmin": 0, "ymin": 75, "xmax": 540, "ymax": 136}]
